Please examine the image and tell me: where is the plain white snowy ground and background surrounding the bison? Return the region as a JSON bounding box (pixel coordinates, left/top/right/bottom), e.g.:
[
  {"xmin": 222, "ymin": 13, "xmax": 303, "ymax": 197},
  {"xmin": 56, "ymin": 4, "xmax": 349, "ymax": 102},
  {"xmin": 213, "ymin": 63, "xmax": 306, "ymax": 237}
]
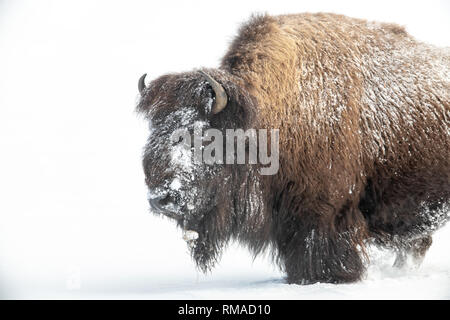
[{"xmin": 0, "ymin": 0, "xmax": 450, "ymax": 299}]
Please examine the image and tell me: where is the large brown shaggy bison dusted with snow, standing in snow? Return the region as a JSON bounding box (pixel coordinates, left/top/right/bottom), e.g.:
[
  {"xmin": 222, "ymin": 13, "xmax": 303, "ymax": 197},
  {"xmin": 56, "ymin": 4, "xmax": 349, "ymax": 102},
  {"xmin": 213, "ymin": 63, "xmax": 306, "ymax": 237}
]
[{"xmin": 137, "ymin": 13, "xmax": 450, "ymax": 284}]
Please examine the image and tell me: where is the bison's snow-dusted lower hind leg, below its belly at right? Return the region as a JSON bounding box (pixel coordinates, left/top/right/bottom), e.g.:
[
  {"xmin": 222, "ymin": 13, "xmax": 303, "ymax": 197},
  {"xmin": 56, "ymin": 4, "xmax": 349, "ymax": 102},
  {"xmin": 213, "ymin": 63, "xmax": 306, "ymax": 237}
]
[{"xmin": 394, "ymin": 235, "xmax": 433, "ymax": 268}]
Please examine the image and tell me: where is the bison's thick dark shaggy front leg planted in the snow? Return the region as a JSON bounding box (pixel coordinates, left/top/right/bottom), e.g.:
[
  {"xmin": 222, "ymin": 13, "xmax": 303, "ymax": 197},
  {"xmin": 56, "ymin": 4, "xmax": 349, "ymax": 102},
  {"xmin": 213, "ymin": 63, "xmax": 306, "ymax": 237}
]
[{"xmin": 278, "ymin": 219, "xmax": 365, "ymax": 284}]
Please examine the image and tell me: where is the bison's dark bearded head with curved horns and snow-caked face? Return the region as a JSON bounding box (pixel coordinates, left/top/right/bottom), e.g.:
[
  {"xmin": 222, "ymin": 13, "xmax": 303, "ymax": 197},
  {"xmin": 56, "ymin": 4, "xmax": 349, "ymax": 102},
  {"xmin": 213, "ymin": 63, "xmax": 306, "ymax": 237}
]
[{"xmin": 137, "ymin": 70, "xmax": 255, "ymax": 270}]
